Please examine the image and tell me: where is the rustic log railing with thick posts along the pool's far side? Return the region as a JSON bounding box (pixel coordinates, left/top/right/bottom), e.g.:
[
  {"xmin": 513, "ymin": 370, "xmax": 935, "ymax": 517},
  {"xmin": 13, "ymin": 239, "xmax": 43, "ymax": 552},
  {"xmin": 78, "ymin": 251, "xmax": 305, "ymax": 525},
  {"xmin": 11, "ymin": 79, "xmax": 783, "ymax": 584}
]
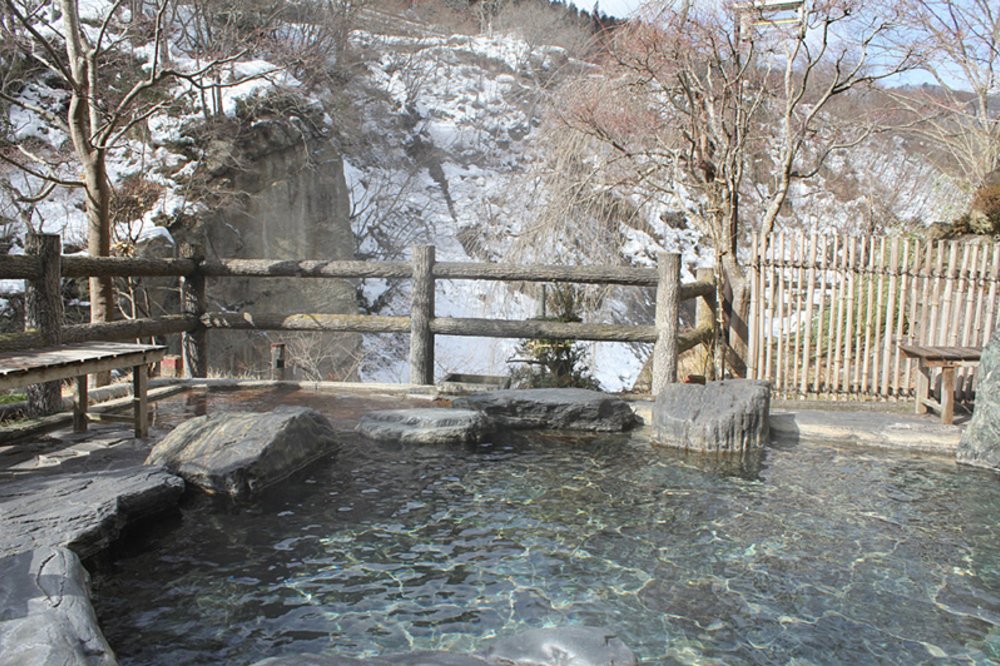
[{"xmin": 0, "ymin": 232, "xmax": 715, "ymax": 394}]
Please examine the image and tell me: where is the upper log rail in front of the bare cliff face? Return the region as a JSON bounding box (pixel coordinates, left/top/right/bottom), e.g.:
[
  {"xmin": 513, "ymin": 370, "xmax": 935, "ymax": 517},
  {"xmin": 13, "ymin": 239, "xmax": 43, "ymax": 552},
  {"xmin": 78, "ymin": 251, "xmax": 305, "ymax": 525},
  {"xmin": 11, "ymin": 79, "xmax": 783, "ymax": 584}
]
[{"xmin": 199, "ymin": 259, "xmax": 413, "ymax": 278}]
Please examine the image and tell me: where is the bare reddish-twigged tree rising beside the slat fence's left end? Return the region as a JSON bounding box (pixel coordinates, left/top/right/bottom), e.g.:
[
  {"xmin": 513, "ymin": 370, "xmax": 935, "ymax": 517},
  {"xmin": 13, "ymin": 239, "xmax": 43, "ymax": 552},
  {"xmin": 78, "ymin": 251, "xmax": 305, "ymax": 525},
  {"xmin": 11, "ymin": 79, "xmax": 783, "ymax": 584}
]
[{"xmin": 566, "ymin": 0, "xmax": 914, "ymax": 373}]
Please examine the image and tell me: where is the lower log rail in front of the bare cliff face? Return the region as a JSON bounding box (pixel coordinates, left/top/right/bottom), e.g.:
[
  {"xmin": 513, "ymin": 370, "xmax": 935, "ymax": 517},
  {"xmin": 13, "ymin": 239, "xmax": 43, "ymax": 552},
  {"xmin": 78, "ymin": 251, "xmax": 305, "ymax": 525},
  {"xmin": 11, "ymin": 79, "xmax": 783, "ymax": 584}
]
[{"xmin": 201, "ymin": 312, "xmax": 410, "ymax": 333}]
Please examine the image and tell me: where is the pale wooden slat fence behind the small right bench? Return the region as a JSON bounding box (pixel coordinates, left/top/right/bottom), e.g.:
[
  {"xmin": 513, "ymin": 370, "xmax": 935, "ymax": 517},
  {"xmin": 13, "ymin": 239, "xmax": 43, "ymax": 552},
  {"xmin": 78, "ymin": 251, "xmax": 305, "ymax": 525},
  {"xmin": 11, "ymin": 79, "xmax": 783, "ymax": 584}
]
[{"xmin": 747, "ymin": 231, "xmax": 1000, "ymax": 400}]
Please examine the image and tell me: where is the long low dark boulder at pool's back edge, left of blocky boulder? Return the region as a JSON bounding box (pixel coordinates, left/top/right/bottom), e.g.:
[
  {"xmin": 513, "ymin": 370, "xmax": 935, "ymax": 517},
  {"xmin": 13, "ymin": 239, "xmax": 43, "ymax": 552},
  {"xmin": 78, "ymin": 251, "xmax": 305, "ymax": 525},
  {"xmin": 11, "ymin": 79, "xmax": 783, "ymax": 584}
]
[{"xmin": 452, "ymin": 388, "xmax": 642, "ymax": 432}]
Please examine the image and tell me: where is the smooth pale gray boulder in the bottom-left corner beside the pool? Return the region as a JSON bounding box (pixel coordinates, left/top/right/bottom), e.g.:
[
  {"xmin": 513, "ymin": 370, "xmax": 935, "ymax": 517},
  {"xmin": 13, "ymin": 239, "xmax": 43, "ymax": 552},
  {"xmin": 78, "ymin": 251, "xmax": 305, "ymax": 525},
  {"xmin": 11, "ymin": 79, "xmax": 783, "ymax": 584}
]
[{"xmin": 0, "ymin": 547, "xmax": 118, "ymax": 666}]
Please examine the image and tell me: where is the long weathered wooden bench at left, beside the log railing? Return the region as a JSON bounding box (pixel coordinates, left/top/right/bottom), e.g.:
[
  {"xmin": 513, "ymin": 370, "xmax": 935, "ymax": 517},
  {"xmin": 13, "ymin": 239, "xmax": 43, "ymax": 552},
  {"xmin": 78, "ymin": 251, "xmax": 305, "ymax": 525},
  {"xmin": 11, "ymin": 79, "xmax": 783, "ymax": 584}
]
[{"xmin": 0, "ymin": 342, "xmax": 167, "ymax": 437}]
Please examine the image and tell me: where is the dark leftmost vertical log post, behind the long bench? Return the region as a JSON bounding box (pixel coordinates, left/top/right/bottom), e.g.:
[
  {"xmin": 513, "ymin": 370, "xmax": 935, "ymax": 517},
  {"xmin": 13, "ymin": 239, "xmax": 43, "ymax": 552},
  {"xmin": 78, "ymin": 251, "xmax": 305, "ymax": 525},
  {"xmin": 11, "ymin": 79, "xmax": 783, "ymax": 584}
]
[{"xmin": 24, "ymin": 234, "xmax": 63, "ymax": 416}]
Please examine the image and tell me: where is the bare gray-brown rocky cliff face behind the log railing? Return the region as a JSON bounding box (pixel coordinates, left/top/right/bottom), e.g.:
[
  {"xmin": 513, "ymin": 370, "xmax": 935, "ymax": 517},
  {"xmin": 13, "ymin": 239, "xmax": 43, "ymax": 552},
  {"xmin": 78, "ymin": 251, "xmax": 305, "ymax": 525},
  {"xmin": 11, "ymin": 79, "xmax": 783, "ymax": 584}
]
[{"xmin": 195, "ymin": 120, "xmax": 360, "ymax": 380}]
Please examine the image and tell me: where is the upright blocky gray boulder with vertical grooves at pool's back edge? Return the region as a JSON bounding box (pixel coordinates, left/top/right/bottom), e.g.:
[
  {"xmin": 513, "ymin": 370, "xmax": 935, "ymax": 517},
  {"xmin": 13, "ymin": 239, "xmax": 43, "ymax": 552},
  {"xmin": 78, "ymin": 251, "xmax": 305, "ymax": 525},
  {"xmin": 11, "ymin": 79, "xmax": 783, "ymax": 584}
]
[{"xmin": 653, "ymin": 379, "xmax": 771, "ymax": 452}]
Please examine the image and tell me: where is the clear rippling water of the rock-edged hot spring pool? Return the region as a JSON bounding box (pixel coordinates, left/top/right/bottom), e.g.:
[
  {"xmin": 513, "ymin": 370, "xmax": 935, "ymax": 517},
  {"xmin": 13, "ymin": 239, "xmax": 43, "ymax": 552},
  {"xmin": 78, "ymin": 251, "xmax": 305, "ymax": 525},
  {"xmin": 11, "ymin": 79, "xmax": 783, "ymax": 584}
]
[{"xmin": 95, "ymin": 386, "xmax": 1000, "ymax": 665}]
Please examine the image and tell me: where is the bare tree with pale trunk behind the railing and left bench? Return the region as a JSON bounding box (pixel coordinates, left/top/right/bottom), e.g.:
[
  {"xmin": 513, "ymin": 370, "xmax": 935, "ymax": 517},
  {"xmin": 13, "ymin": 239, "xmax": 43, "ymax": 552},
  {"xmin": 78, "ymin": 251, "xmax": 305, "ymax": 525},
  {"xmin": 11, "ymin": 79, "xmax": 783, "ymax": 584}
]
[{"xmin": 0, "ymin": 0, "xmax": 274, "ymax": 352}]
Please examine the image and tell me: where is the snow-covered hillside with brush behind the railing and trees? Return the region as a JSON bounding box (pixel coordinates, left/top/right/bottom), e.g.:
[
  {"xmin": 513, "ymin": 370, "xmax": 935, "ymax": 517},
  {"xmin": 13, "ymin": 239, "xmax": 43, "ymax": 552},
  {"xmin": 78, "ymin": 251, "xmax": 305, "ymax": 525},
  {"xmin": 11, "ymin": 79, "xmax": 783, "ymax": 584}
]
[{"xmin": 0, "ymin": 0, "xmax": 968, "ymax": 390}]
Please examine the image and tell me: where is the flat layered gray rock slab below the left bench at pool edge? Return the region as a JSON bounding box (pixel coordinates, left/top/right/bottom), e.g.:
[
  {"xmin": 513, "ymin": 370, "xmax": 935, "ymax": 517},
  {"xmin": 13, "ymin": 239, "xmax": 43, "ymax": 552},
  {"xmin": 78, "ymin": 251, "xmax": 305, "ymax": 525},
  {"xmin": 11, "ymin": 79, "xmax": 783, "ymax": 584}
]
[{"xmin": 0, "ymin": 466, "xmax": 184, "ymax": 557}]
